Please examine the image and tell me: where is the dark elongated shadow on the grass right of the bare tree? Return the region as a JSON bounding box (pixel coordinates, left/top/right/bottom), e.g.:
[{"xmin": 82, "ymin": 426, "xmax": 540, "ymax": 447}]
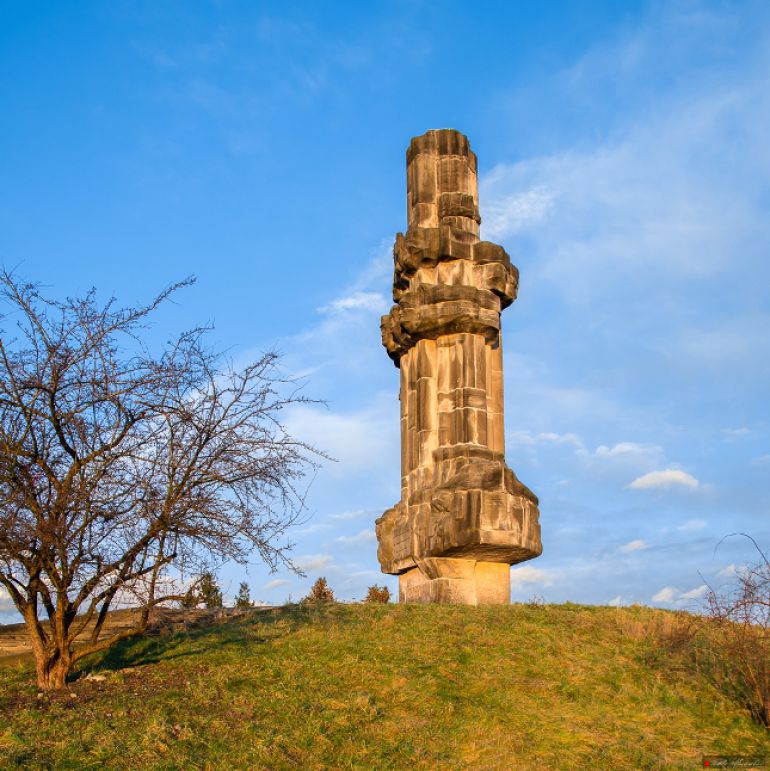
[{"xmin": 76, "ymin": 605, "xmax": 328, "ymax": 676}]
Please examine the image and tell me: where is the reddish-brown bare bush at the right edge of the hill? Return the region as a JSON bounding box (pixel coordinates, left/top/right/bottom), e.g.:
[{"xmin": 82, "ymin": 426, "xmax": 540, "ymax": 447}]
[{"xmin": 706, "ymin": 536, "xmax": 770, "ymax": 728}]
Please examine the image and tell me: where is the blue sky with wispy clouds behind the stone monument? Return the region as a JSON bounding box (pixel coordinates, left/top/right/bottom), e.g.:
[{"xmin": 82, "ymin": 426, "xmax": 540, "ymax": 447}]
[{"xmin": 0, "ymin": 0, "xmax": 770, "ymax": 610}]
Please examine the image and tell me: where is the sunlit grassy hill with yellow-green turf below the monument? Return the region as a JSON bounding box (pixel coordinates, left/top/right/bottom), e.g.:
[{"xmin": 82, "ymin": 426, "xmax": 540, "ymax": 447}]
[{"xmin": 0, "ymin": 605, "xmax": 770, "ymax": 769}]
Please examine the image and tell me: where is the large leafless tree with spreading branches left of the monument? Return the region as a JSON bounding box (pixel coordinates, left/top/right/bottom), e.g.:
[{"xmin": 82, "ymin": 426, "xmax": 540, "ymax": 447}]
[{"xmin": 0, "ymin": 272, "xmax": 320, "ymax": 689}]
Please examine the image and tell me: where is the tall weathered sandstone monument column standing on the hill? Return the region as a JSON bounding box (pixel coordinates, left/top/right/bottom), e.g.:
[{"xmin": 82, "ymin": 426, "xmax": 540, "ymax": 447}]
[{"xmin": 376, "ymin": 129, "xmax": 542, "ymax": 605}]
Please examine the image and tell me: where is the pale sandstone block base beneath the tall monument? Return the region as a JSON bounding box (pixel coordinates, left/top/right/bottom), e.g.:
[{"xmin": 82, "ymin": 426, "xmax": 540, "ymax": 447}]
[{"xmin": 398, "ymin": 557, "xmax": 511, "ymax": 605}]
